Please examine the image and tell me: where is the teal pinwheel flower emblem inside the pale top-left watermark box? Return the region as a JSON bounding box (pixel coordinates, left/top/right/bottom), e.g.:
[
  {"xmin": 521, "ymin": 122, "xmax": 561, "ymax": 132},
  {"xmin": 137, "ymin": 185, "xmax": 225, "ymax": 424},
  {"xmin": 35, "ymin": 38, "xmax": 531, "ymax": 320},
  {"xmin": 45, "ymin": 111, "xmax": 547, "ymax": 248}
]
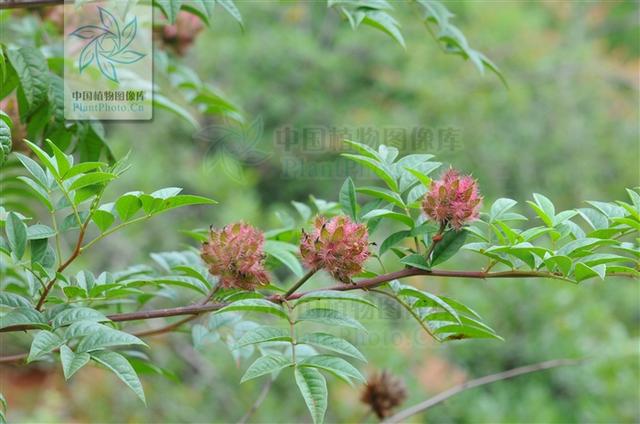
[{"xmin": 69, "ymin": 7, "xmax": 146, "ymax": 82}]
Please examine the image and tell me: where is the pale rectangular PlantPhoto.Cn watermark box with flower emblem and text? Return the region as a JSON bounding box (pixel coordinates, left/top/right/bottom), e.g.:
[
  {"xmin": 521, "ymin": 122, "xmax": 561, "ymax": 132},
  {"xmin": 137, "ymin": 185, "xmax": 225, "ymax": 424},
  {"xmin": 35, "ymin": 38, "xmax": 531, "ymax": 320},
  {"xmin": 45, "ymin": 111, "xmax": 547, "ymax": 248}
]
[{"xmin": 64, "ymin": 0, "xmax": 153, "ymax": 120}]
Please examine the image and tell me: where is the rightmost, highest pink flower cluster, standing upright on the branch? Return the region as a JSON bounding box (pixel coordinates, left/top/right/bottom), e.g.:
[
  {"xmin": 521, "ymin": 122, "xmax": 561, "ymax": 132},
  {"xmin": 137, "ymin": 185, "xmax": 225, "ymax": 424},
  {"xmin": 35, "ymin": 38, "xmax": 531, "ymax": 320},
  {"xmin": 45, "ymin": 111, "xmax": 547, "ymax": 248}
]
[{"xmin": 422, "ymin": 169, "xmax": 482, "ymax": 230}]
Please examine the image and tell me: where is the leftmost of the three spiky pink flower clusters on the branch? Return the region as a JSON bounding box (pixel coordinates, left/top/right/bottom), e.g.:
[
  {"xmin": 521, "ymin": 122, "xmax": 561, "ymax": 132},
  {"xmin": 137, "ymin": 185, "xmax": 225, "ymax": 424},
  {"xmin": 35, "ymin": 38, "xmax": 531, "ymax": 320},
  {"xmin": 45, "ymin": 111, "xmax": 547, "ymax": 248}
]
[{"xmin": 201, "ymin": 222, "xmax": 269, "ymax": 290}]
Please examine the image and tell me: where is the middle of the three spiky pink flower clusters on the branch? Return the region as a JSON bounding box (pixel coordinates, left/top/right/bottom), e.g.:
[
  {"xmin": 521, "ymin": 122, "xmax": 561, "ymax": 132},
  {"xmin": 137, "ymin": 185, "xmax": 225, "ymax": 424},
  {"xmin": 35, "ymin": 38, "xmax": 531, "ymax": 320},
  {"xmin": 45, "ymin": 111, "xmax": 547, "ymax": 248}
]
[{"xmin": 300, "ymin": 216, "xmax": 369, "ymax": 282}]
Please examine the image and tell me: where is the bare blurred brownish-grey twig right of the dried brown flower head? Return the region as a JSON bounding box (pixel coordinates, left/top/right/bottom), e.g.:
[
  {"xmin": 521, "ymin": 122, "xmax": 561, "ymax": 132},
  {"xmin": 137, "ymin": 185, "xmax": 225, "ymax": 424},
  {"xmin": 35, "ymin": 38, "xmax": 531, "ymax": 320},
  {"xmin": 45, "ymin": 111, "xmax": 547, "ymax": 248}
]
[{"xmin": 383, "ymin": 359, "xmax": 585, "ymax": 424}]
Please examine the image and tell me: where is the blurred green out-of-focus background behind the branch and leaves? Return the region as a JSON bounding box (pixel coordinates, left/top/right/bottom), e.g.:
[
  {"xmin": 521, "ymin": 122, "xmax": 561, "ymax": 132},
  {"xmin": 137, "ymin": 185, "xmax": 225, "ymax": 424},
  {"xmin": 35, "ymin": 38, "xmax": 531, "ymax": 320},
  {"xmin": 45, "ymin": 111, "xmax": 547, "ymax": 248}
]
[{"xmin": 2, "ymin": 1, "xmax": 640, "ymax": 423}]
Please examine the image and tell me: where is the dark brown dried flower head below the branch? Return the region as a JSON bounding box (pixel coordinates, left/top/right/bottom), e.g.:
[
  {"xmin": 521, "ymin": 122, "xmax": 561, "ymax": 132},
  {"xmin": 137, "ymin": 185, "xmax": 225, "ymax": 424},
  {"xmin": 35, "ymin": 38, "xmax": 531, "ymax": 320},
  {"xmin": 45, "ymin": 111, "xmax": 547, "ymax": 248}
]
[{"xmin": 360, "ymin": 371, "xmax": 407, "ymax": 420}]
